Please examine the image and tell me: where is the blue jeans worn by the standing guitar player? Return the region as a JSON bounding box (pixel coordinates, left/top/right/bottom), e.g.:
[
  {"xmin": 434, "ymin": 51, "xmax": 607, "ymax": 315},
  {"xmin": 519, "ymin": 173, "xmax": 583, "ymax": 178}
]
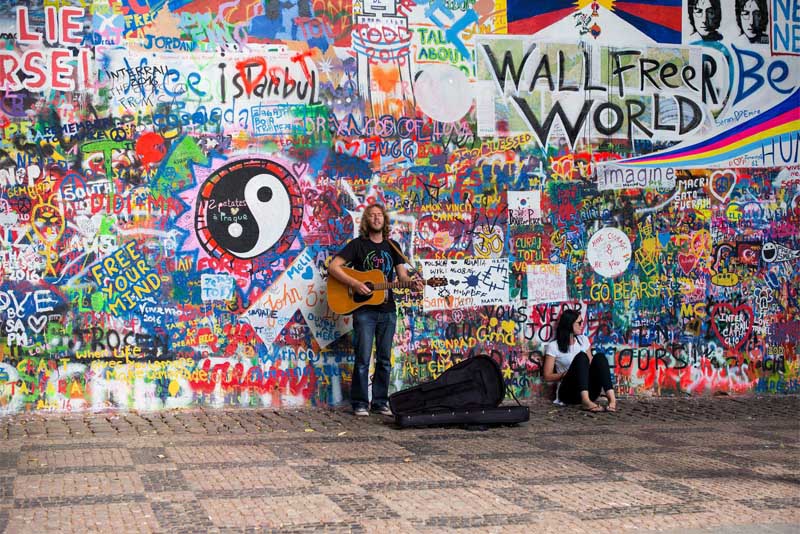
[{"xmin": 350, "ymin": 308, "xmax": 397, "ymax": 410}]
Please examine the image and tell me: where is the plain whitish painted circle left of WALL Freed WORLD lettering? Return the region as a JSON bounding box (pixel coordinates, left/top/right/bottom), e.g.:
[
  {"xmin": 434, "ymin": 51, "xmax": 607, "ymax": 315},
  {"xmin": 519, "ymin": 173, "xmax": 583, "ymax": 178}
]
[{"xmin": 414, "ymin": 65, "xmax": 473, "ymax": 122}]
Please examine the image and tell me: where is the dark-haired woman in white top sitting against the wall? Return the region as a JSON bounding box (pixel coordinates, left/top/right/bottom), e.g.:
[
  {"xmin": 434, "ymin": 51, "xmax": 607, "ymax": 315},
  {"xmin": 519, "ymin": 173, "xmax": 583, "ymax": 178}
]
[{"xmin": 544, "ymin": 310, "xmax": 617, "ymax": 412}]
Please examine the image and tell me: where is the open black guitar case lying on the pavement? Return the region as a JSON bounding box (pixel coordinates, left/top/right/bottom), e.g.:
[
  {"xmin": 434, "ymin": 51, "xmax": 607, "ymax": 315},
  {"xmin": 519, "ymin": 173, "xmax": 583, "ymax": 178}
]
[{"xmin": 389, "ymin": 356, "xmax": 530, "ymax": 427}]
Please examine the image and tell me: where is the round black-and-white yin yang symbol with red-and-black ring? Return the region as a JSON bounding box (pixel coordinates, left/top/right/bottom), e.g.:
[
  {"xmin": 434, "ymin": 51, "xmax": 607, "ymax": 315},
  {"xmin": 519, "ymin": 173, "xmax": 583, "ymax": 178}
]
[{"xmin": 195, "ymin": 159, "xmax": 303, "ymax": 260}]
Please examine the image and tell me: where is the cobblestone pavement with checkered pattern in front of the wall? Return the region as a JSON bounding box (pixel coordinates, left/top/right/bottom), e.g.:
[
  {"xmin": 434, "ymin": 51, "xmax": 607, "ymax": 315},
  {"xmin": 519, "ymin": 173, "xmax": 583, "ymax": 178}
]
[{"xmin": 0, "ymin": 396, "xmax": 800, "ymax": 534}]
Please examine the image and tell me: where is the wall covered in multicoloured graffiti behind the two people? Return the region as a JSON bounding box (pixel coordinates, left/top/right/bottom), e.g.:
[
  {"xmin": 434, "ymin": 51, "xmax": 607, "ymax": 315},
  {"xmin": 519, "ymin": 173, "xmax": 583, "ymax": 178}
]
[{"xmin": 0, "ymin": 0, "xmax": 800, "ymax": 413}]
